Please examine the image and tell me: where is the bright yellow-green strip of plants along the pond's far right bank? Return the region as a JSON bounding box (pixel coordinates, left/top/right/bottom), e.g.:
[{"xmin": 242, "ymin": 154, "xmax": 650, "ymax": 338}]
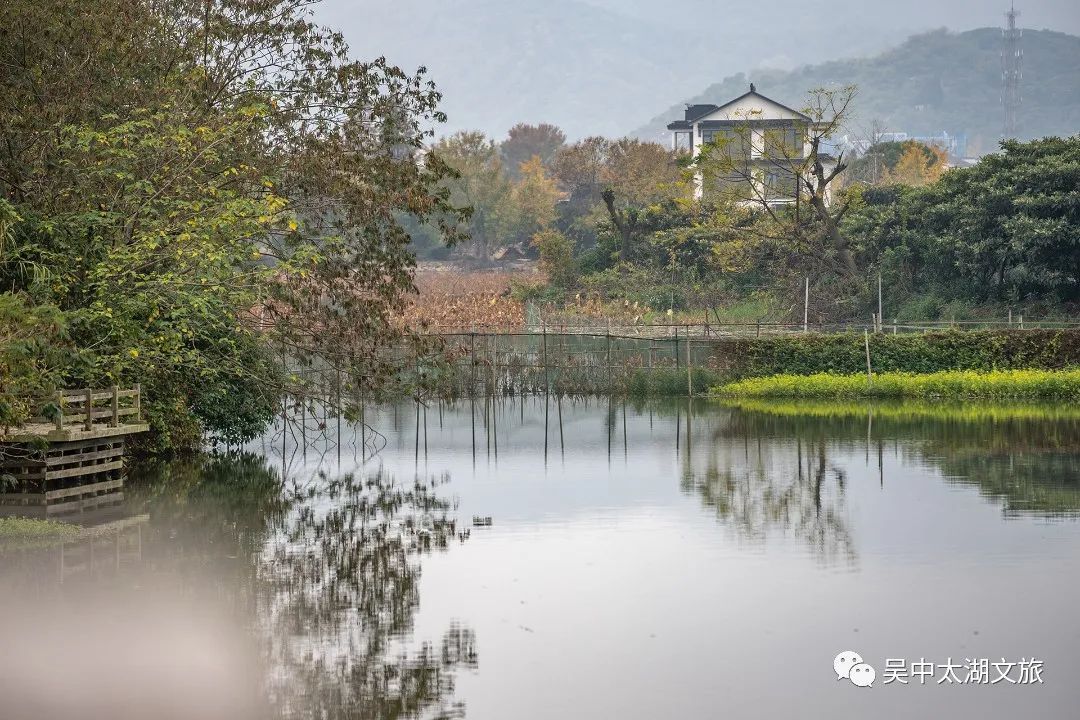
[{"xmin": 712, "ymin": 370, "xmax": 1080, "ymax": 399}]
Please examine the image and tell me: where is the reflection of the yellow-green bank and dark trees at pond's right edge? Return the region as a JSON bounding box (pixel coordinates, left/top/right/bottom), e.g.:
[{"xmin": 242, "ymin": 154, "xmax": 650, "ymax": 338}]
[{"xmin": 721, "ymin": 403, "xmax": 1080, "ymax": 518}]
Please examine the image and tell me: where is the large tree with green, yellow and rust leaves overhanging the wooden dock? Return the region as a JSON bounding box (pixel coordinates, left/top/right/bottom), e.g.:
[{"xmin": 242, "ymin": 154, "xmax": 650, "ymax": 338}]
[{"xmin": 0, "ymin": 0, "xmax": 462, "ymax": 448}]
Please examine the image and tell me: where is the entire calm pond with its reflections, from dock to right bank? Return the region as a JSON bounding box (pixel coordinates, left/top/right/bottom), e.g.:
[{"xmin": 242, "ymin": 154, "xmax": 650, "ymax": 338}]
[{"xmin": 0, "ymin": 397, "xmax": 1080, "ymax": 720}]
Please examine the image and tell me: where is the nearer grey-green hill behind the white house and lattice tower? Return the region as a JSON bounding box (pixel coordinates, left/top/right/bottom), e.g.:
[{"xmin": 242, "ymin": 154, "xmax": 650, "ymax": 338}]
[{"xmin": 635, "ymin": 28, "xmax": 1080, "ymax": 154}]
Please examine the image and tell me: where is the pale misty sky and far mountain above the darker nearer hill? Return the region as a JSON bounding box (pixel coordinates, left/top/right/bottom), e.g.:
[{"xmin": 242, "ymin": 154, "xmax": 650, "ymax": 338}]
[{"xmin": 314, "ymin": 0, "xmax": 1062, "ymax": 139}]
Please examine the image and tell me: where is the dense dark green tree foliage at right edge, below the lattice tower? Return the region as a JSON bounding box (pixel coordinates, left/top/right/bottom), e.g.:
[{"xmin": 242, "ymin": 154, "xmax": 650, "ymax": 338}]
[{"xmin": 845, "ymin": 136, "xmax": 1080, "ymax": 307}]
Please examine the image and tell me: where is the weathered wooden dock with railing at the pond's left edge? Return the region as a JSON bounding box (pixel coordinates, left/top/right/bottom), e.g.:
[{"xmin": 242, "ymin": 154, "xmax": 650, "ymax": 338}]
[{"xmin": 0, "ymin": 385, "xmax": 149, "ymax": 517}]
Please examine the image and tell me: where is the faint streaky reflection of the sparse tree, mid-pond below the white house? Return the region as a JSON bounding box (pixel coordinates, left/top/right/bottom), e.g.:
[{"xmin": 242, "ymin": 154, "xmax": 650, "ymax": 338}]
[{"xmin": 681, "ymin": 403, "xmax": 856, "ymax": 565}]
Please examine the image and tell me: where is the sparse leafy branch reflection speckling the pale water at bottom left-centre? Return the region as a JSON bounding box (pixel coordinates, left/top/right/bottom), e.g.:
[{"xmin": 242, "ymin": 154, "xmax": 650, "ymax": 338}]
[{"xmin": 258, "ymin": 472, "xmax": 476, "ymax": 719}]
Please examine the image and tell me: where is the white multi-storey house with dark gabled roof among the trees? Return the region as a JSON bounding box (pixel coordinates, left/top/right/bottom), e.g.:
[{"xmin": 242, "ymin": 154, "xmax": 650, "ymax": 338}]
[{"xmin": 667, "ymin": 83, "xmax": 835, "ymax": 205}]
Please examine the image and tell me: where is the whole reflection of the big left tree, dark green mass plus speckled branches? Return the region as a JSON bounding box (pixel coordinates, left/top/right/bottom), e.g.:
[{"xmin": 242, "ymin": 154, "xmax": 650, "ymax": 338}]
[{"xmin": 130, "ymin": 456, "xmax": 477, "ymax": 719}]
